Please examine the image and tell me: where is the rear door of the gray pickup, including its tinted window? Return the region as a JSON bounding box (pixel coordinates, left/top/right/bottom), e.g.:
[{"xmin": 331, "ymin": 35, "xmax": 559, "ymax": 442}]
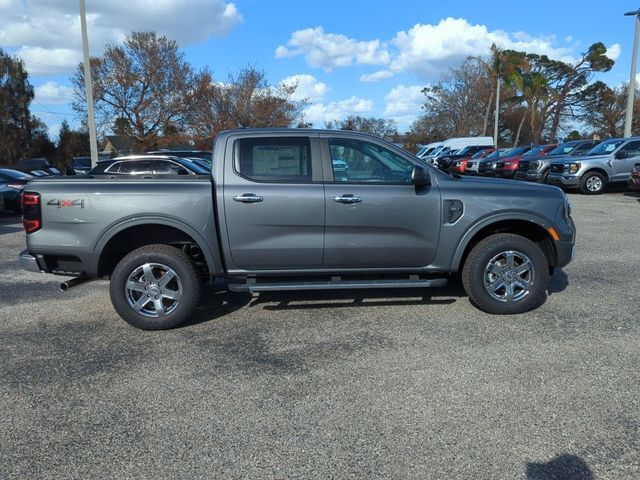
[{"xmin": 223, "ymin": 134, "xmax": 325, "ymax": 271}]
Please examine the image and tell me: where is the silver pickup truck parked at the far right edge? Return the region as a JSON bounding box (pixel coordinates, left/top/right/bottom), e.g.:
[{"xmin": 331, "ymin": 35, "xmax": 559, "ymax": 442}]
[{"xmin": 547, "ymin": 137, "xmax": 640, "ymax": 195}]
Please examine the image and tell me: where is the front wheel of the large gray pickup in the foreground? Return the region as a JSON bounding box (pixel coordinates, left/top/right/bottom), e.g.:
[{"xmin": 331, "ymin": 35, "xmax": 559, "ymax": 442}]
[{"xmin": 462, "ymin": 233, "xmax": 549, "ymax": 315}]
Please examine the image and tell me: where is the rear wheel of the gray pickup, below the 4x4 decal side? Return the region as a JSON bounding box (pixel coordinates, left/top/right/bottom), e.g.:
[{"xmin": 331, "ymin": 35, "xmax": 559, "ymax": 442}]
[{"xmin": 109, "ymin": 245, "xmax": 200, "ymax": 330}]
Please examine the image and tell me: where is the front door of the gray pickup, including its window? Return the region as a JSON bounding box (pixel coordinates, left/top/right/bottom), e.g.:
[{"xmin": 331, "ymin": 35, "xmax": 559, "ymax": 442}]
[{"xmin": 322, "ymin": 136, "xmax": 441, "ymax": 269}]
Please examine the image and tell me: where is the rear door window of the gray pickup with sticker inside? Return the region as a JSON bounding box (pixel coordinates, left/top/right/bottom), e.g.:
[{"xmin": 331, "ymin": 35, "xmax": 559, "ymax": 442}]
[{"xmin": 235, "ymin": 137, "xmax": 311, "ymax": 183}]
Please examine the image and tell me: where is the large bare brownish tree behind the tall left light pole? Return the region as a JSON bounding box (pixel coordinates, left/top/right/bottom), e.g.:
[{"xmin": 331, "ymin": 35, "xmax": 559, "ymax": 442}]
[{"xmin": 71, "ymin": 32, "xmax": 210, "ymax": 148}]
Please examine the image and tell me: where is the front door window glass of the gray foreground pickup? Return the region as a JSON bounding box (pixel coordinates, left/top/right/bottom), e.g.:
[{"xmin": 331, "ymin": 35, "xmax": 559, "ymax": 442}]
[{"xmin": 329, "ymin": 138, "xmax": 414, "ymax": 184}]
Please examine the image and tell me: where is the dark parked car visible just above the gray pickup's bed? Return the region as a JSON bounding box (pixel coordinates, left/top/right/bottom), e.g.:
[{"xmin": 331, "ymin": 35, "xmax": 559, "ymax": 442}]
[{"xmin": 89, "ymin": 155, "xmax": 209, "ymax": 176}]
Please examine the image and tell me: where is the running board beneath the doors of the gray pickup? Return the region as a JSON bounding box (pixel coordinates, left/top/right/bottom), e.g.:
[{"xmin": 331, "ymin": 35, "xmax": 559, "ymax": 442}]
[{"xmin": 229, "ymin": 278, "xmax": 447, "ymax": 293}]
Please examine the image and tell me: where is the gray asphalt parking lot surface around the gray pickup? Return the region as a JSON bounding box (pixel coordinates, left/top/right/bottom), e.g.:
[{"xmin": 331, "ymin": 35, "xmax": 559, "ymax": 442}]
[{"xmin": 0, "ymin": 191, "xmax": 640, "ymax": 479}]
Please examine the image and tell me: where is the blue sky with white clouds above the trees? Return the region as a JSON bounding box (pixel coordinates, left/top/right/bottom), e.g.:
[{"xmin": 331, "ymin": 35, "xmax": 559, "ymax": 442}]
[{"xmin": 0, "ymin": 0, "xmax": 640, "ymax": 140}]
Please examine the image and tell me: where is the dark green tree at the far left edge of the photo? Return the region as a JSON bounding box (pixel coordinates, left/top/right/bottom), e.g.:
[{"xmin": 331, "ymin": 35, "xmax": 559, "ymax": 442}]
[{"xmin": 0, "ymin": 49, "xmax": 34, "ymax": 163}]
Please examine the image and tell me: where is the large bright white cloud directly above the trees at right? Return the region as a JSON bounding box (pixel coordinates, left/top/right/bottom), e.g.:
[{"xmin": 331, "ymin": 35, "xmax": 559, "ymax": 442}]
[{"xmin": 390, "ymin": 18, "xmax": 572, "ymax": 79}]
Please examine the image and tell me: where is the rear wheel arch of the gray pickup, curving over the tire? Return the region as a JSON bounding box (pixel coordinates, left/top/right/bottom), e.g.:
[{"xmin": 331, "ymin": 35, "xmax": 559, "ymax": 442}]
[{"xmin": 94, "ymin": 217, "xmax": 222, "ymax": 276}]
